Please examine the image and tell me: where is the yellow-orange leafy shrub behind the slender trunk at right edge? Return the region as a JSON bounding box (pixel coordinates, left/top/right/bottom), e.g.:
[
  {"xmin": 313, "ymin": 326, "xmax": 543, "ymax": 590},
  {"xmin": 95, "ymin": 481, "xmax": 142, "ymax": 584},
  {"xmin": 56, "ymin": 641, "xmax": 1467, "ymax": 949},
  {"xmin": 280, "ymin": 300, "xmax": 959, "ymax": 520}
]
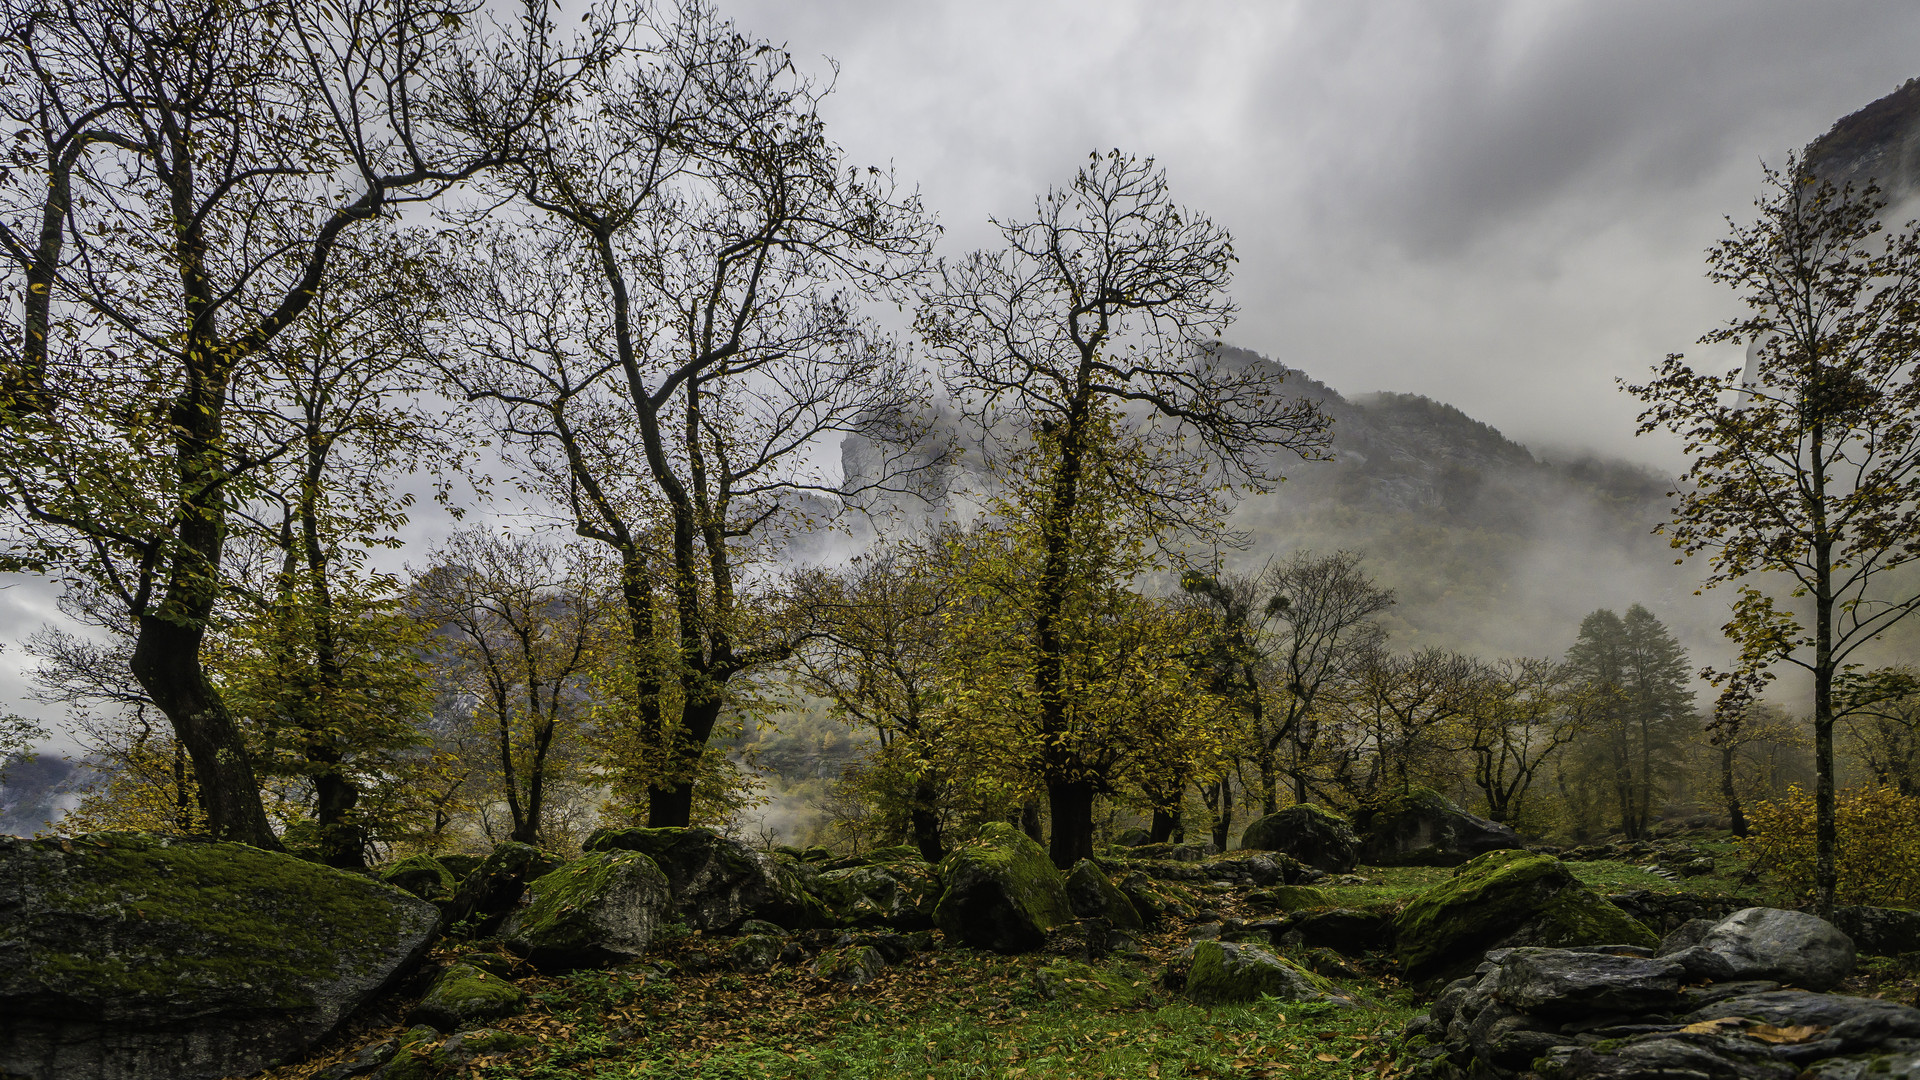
[{"xmin": 1747, "ymin": 784, "xmax": 1920, "ymax": 907}]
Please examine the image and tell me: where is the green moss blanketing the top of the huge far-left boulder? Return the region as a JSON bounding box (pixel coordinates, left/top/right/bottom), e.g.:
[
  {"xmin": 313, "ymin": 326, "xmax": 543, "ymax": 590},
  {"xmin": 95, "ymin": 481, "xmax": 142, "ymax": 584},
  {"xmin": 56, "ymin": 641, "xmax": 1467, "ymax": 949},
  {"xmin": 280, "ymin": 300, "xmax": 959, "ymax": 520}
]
[{"xmin": 0, "ymin": 834, "xmax": 428, "ymax": 1007}]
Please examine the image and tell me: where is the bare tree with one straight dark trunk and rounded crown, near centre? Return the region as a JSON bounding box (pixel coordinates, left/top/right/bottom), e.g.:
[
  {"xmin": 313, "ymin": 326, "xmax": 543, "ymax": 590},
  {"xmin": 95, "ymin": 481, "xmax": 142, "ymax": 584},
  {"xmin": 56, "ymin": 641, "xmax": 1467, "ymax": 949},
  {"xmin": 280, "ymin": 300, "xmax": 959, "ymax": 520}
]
[{"xmin": 918, "ymin": 150, "xmax": 1327, "ymax": 867}]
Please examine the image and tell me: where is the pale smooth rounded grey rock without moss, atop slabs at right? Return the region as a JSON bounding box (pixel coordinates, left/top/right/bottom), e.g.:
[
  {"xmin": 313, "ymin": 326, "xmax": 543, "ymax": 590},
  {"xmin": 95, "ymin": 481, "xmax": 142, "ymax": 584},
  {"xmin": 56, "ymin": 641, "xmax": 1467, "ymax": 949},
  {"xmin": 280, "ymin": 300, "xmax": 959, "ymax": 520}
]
[{"xmin": 1670, "ymin": 907, "xmax": 1853, "ymax": 990}]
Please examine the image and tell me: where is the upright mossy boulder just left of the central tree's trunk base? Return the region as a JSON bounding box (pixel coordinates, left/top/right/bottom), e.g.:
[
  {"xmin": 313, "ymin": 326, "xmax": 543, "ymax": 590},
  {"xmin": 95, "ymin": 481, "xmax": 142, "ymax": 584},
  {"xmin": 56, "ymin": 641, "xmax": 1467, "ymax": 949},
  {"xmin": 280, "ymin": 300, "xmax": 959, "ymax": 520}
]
[{"xmin": 933, "ymin": 821, "xmax": 1073, "ymax": 953}]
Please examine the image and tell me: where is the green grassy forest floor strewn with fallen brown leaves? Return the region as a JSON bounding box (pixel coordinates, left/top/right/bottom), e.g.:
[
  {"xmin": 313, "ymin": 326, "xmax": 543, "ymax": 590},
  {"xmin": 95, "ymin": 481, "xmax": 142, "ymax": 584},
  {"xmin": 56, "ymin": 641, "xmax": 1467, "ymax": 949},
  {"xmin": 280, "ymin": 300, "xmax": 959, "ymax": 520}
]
[{"xmin": 261, "ymin": 846, "xmax": 1920, "ymax": 1080}]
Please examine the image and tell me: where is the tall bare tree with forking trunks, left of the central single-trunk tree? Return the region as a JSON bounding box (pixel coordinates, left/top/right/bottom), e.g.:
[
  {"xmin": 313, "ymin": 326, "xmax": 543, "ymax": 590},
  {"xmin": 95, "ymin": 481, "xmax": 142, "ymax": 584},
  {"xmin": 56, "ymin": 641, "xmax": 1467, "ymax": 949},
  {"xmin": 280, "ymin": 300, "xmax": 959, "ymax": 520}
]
[{"xmin": 449, "ymin": 4, "xmax": 931, "ymax": 826}]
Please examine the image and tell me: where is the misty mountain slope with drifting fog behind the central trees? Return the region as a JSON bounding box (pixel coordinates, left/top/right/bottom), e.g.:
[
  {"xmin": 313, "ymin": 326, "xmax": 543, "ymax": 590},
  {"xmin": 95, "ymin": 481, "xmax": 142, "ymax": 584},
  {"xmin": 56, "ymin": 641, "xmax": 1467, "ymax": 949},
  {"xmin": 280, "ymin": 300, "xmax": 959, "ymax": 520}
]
[{"xmin": 841, "ymin": 346, "xmax": 1726, "ymax": 663}]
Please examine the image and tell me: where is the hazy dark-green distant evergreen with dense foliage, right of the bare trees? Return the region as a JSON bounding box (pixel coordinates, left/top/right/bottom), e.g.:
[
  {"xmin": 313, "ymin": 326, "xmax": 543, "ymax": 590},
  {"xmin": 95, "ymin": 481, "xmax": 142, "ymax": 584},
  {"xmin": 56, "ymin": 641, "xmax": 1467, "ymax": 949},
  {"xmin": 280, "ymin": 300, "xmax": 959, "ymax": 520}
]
[{"xmin": 1567, "ymin": 603, "xmax": 1699, "ymax": 838}]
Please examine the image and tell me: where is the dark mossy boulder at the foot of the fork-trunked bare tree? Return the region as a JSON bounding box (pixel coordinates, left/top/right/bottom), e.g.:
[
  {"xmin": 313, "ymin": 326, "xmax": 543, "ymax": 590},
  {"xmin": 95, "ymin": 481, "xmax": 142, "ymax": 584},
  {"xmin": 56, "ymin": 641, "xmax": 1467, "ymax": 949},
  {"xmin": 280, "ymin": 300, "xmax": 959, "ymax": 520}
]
[{"xmin": 586, "ymin": 828, "xmax": 831, "ymax": 932}]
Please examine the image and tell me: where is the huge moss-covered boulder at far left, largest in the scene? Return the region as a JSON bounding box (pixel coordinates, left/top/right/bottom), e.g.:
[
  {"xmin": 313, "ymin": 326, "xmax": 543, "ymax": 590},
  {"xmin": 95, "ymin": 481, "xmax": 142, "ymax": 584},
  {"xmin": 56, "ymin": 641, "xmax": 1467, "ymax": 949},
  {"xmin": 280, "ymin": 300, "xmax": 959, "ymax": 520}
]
[{"xmin": 0, "ymin": 834, "xmax": 440, "ymax": 1080}]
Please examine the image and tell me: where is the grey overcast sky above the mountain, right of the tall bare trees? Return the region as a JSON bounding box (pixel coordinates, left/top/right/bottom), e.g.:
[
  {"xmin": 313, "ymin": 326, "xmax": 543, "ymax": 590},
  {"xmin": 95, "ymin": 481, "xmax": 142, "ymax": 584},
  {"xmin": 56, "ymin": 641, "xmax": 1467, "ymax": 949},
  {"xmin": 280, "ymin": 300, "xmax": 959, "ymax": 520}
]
[{"xmin": 722, "ymin": 0, "xmax": 1920, "ymax": 471}]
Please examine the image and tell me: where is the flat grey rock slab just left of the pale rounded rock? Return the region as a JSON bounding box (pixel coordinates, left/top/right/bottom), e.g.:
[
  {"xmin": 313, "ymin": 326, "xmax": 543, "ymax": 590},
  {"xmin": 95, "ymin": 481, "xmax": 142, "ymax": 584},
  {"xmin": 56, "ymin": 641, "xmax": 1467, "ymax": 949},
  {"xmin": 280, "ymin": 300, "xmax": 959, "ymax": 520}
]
[{"xmin": 1498, "ymin": 949, "xmax": 1686, "ymax": 1019}]
